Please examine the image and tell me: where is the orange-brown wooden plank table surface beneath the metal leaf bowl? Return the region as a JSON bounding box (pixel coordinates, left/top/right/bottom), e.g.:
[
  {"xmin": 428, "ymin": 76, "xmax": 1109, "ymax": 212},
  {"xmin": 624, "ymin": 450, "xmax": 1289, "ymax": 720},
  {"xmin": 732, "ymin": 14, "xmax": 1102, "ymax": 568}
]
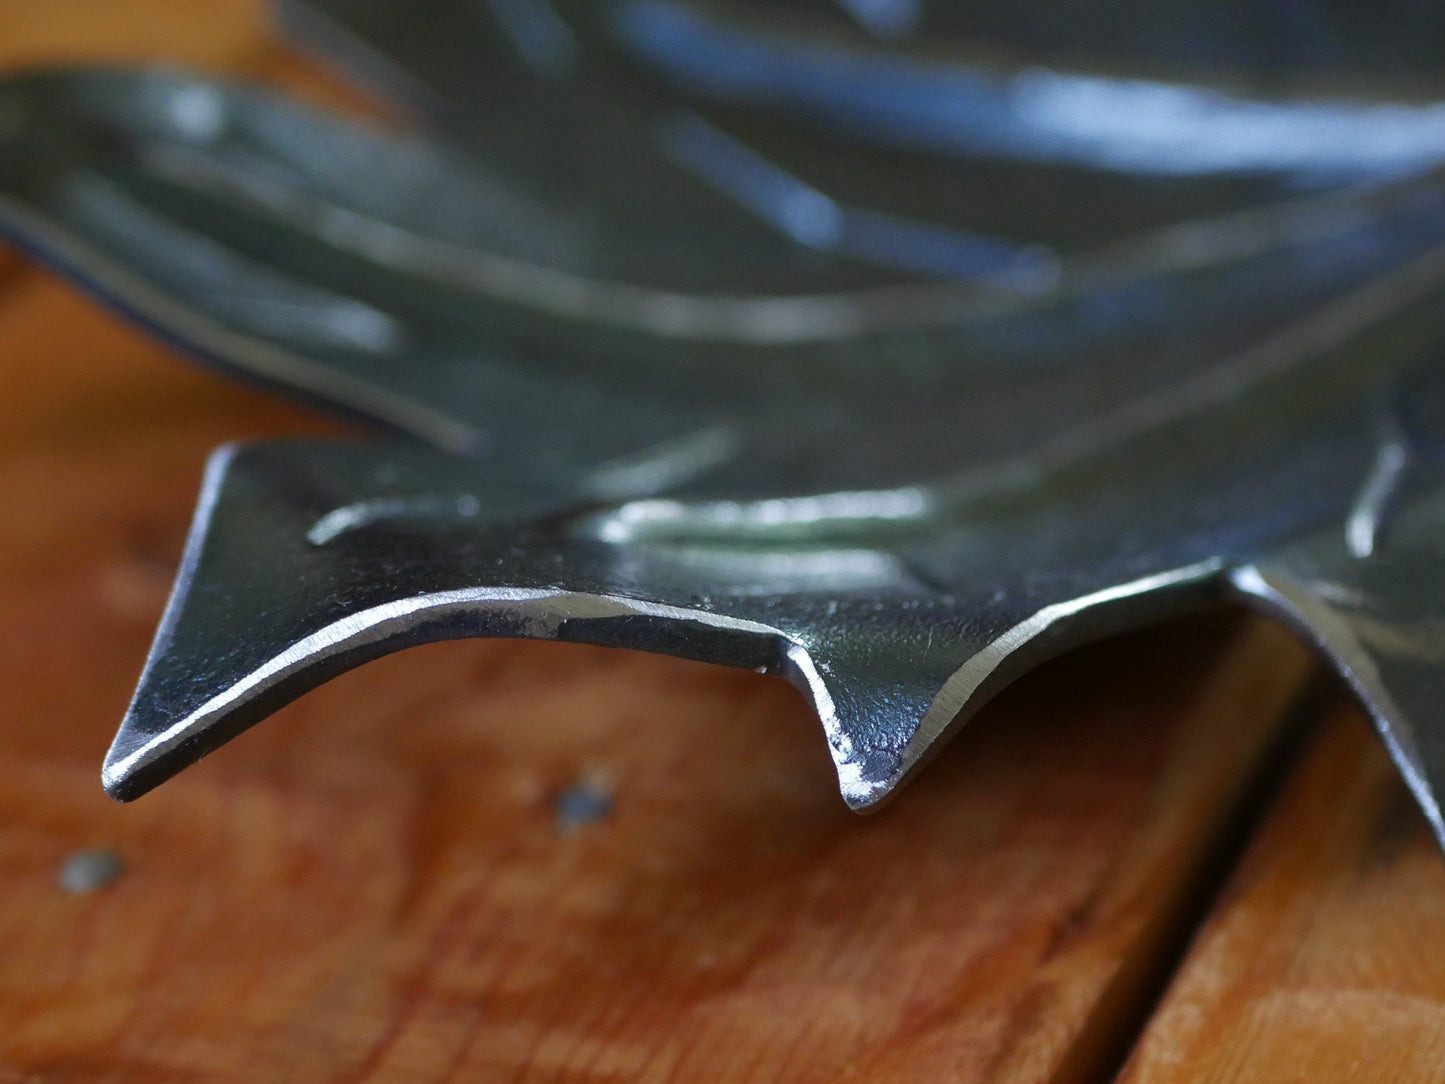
[{"xmin": 0, "ymin": 0, "xmax": 1445, "ymax": 1084}]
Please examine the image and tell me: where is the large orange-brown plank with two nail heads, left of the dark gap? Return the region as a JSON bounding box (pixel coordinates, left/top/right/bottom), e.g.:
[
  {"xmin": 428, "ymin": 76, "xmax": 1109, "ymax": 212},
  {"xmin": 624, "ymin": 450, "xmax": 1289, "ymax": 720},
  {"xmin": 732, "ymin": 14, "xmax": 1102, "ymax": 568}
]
[{"xmin": 0, "ymin": 341, "xmax": 1303, "ymax": 1080}]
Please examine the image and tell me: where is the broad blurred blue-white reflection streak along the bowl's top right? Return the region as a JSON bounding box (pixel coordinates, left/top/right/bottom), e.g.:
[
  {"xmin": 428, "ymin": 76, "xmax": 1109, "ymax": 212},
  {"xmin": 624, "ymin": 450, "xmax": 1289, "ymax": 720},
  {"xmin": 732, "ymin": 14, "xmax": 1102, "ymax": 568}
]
[{"xmin": 613, "ymin": 0, "xmax": 1445, "ymax": 176}]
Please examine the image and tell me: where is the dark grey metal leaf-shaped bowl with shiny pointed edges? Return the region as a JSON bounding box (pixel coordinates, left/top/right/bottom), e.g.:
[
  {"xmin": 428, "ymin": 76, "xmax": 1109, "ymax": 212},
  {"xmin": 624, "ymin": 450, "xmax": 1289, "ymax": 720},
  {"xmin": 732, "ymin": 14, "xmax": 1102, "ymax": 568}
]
[{"xmin": 0, "ymin": 0, "xmax": 1445, "ymax": 834}]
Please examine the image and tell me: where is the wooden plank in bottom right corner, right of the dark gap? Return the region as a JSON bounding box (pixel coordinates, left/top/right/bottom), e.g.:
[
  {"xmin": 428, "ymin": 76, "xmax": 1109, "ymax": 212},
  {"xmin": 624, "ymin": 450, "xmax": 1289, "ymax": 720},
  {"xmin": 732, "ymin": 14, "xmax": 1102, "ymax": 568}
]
[{"xmin": 1124, "ymin": 707, "xmax": 1445, "ymax": 1084}]
